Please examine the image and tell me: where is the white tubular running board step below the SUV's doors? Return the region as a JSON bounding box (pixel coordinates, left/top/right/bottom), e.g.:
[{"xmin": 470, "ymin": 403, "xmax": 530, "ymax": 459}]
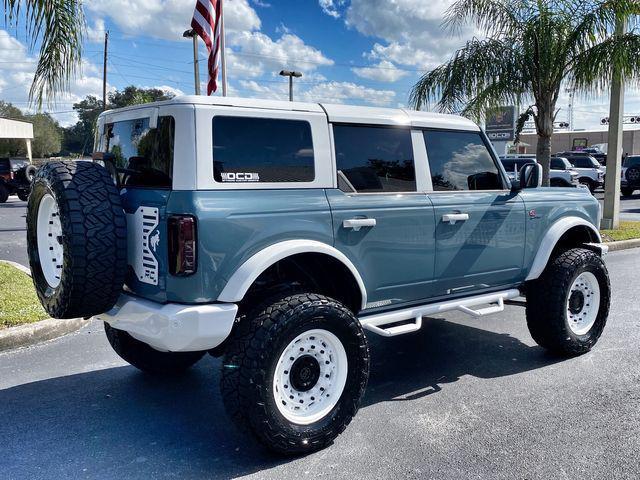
[{"xmin": 360, "ymin": 288, "xmax": 520, "ymax": 337}]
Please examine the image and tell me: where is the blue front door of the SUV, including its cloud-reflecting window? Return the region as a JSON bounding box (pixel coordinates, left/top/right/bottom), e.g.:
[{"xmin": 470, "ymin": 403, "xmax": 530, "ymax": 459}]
[{"xmin": 423, "ymin": 130, "xmax": 525, "ymax": 295}]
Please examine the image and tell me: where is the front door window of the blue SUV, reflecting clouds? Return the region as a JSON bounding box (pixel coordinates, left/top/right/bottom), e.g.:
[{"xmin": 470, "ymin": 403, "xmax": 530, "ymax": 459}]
[{"xmin": 424, "ymin": 130, "xmax": 504, "ymax": 191}]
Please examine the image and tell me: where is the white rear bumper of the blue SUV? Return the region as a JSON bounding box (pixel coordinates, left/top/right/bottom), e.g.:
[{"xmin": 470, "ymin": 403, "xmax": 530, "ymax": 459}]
[{"xmin": 96, "ymin": 294, "xmax": 238, "ymax": 352}]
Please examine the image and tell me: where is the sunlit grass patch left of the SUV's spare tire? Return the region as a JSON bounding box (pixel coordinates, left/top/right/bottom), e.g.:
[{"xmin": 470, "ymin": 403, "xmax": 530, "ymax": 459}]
[{"xmin": 0, "ymin": 263, "xmax": 48, "ymax": 330}]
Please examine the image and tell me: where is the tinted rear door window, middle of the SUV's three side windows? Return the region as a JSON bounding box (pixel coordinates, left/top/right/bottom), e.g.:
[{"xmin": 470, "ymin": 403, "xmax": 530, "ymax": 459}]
[{"xmin": 333, "ymin": 125, "xmax": 416, "ymax": 192}]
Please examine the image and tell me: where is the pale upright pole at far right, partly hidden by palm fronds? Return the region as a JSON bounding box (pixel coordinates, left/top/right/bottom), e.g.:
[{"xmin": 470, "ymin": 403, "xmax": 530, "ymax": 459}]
[{"xmin": 601, "ymin": 18, "xmax": 626, "ymax": 229}]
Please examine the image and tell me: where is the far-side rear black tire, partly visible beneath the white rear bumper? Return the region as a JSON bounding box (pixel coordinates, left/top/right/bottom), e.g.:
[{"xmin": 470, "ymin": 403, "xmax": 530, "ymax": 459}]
[{"xmin": 104, "ymin": 322, "xmax": 207, "ymax": 375}]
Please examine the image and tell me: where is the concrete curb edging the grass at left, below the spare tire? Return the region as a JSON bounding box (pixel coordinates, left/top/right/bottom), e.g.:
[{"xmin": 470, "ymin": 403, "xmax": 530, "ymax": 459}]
[{"xmin": 0, "ymin": 318, "xmax": 90, "ymax": 352}]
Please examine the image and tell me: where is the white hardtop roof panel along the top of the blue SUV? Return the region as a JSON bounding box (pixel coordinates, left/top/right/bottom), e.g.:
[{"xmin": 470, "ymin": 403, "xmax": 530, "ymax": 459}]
[{"xmin": 102, "ymin": 95, "xmax": 480, "ymax": 131}]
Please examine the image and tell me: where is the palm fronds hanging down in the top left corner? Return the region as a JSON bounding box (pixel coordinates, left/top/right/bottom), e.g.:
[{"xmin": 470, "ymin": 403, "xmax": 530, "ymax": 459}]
[{"xmin": 4, "ymin": 0, "xmax": 85, "ymax": 107}]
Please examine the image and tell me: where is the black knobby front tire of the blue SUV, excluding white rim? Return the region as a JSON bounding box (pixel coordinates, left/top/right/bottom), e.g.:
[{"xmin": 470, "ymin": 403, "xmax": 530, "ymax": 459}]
[{"xmin": 526, "ymin": 248, "xmax": 611, "ymax": 356}]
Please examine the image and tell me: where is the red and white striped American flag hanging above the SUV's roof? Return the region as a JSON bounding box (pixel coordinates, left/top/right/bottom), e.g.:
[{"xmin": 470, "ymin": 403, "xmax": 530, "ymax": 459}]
[{"xmin": 191, "ymin": 0, "xmax": 222, "ymax": 95}]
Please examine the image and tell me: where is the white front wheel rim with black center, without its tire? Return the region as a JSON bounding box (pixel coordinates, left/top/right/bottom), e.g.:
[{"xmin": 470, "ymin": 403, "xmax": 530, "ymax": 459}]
[{"xmin": 566, "ymin": 272, "xmax": 600, "ymax": 335}]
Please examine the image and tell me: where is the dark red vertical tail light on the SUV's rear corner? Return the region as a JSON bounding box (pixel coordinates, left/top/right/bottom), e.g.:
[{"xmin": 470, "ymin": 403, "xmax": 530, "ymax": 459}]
[{"xmin": 169, "ymin": 215, "xmax": 198, "ymax": 277}]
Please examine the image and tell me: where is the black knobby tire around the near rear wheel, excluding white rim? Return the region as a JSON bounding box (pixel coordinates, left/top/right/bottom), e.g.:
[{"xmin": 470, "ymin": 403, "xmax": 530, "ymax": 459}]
[{"xmin": 221, "ymin": 293, "xmax": 370, "ymax": 455}]
